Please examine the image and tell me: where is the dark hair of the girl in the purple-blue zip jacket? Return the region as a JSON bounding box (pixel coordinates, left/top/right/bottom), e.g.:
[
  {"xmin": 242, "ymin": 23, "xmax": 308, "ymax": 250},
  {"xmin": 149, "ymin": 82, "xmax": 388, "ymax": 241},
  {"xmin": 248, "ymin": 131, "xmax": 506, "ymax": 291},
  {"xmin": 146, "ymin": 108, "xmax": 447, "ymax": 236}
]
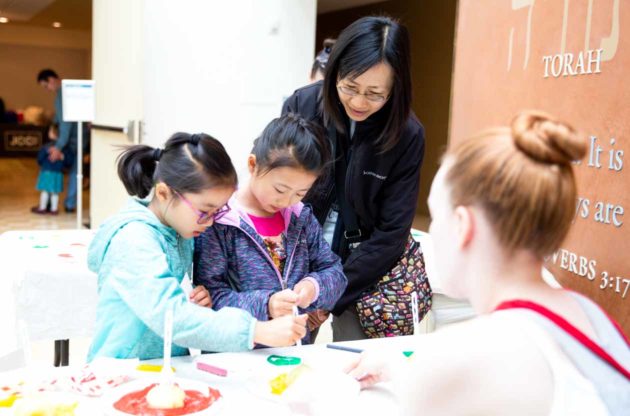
[{"xmin": 252, "ymin": 113, "xmax": 331, "ymax": 175}]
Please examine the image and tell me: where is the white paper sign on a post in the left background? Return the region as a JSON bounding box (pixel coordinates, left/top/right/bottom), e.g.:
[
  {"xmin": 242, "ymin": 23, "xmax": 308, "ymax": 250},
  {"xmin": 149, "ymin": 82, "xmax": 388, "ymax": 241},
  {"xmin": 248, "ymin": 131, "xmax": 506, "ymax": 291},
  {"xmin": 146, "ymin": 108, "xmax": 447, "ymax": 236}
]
[{"xmin": 61, "ymin": 79, "xmax": 95, "ymax": 121}]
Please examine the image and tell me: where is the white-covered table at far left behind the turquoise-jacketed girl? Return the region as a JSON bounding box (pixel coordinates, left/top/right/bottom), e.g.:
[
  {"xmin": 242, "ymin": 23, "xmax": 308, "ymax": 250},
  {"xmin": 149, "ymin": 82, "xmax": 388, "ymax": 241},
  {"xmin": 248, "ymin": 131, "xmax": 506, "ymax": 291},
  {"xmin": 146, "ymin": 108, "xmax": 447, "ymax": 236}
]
[{"xmin": 0, "ymin": 230, "xmax": 98, "ymax": 364}]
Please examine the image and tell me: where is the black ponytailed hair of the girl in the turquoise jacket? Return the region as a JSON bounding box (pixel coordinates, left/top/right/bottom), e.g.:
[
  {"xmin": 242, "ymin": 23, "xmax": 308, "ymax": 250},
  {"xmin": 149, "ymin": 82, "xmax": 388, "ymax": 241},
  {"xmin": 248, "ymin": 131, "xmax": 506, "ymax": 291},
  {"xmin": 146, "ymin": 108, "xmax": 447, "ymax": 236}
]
[{"xmin": 117, "ymin": 133, "xmax": 237, "ymax": 198}]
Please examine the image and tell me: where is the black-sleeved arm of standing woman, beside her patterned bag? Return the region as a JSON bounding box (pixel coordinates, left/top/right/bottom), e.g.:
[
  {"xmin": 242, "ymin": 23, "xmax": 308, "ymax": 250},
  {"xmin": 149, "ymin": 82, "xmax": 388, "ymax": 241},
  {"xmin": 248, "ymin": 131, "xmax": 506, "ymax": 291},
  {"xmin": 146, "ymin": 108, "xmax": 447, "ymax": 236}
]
[{"xmin": 333, "ymin": 128, "xmax": 424, "ymax": 315}]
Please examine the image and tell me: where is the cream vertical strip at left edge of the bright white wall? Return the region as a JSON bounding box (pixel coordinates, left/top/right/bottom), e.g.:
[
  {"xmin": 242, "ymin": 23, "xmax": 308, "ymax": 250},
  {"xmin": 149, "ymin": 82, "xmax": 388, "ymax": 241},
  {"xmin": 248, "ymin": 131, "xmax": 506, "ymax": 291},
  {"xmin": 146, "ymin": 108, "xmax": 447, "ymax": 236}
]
[{"xmin": 90, "ymin": 0, "xmax": 144, "ymax": 228}]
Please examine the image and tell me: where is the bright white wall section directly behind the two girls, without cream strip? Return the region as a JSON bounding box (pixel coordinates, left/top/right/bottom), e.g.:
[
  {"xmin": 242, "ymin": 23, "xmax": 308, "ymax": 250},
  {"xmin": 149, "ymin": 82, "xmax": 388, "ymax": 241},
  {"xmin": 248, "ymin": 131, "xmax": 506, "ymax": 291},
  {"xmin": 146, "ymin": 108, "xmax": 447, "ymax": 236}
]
[{"xmin": 144, "ymin": 0, "xmax": 316, "ymax": 177}]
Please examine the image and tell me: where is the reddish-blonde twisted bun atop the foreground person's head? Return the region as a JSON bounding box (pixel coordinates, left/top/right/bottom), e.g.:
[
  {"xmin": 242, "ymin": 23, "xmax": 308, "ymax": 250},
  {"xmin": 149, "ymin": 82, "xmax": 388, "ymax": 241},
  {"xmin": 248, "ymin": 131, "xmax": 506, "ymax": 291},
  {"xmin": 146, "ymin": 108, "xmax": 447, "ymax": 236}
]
[{"xmin": 511, "ymin": 111, "xmax": 587, "ymax": 165}]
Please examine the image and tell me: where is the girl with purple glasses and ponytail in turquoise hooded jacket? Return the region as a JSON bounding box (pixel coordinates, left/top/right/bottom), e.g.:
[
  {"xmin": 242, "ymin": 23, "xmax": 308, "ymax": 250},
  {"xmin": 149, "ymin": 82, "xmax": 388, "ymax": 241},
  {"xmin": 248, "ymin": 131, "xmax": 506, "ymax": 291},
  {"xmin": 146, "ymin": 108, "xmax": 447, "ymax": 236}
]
[{"xmin": 88, "ymin": 133, "xmax": 306, "ymax": 361}]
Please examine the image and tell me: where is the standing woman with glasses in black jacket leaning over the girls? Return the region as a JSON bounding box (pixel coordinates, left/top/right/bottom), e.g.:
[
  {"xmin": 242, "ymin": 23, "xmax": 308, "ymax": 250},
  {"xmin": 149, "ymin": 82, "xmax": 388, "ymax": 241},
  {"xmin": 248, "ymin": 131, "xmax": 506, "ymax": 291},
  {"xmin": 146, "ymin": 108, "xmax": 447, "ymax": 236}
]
[{"xmin": 283, "ymin": 17, "xmax": 424, "ymax": 341}]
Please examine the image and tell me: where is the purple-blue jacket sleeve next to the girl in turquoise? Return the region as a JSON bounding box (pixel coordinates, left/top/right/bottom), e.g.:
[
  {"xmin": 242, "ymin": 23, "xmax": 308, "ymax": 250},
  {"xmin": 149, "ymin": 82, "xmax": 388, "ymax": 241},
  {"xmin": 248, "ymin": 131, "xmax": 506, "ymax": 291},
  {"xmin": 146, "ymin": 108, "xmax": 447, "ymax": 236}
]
[{"xmin": 194, "ymin": 226, "xmax": 274, "ymax": 321}]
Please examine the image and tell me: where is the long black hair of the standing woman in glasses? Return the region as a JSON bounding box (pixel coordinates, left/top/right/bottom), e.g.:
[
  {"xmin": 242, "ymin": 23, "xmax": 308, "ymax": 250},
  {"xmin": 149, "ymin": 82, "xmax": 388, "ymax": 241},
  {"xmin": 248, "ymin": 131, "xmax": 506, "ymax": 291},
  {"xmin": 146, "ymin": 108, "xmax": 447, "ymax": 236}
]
[{"xmin": 323, "ymin": 16, "xmax": 411, "ymax": 151}]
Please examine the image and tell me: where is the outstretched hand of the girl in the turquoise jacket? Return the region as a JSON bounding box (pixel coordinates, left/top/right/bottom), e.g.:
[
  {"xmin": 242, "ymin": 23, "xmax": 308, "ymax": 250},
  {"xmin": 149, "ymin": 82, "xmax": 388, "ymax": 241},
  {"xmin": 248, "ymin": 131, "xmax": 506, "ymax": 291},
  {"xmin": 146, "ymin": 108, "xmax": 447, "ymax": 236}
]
[{"xmin": 254, "ymin": 314, "xmax": 307, "ymax": 347}]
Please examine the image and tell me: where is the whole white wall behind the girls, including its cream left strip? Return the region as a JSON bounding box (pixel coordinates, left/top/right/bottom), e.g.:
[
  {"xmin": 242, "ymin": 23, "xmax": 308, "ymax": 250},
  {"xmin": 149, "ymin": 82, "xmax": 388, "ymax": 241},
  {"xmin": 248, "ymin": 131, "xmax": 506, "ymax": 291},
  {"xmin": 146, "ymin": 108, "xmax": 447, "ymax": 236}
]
[{"xmin": 90, "ymin": 0, "xmax": 316, "ymax": 227}]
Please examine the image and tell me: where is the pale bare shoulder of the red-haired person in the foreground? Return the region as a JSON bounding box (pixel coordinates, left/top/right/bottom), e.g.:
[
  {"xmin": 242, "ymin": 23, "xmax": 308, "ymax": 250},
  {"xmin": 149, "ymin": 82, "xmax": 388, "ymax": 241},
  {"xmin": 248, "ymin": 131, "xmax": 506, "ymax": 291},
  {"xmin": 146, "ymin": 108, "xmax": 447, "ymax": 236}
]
[{"xmin": 400, "ymin": 316, "xmax": 553, "ymax": 415}]
